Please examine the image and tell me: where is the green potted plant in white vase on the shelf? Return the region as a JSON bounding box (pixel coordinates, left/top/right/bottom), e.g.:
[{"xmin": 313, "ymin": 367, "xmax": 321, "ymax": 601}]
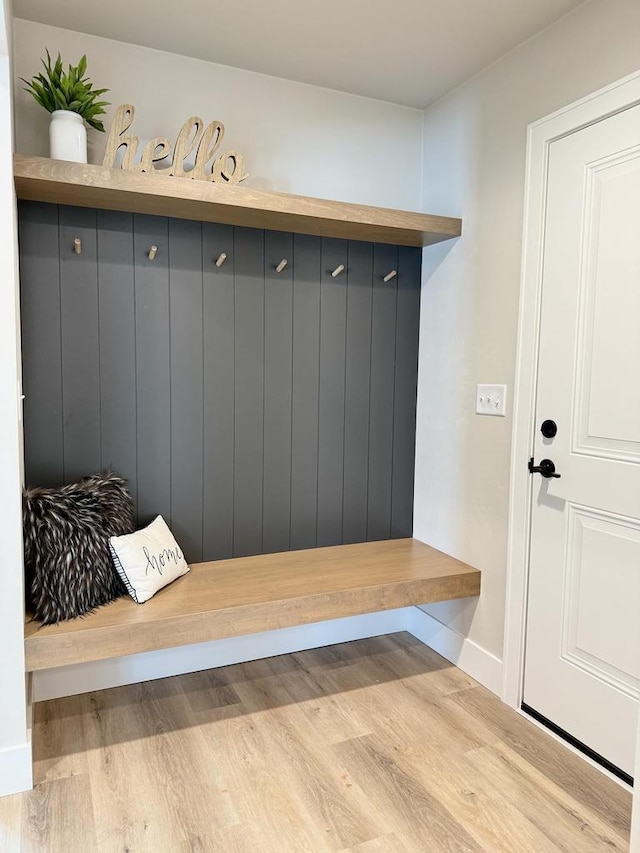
[{"xmin": 20, "ymin": 50, "xmax": 109, "ymax": 163}]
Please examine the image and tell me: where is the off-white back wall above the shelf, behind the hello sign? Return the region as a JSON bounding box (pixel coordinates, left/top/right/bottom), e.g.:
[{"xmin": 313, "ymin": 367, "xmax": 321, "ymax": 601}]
[{"xmin": 14, "ymin": 20, "xmax": 422, "ymax": 210}]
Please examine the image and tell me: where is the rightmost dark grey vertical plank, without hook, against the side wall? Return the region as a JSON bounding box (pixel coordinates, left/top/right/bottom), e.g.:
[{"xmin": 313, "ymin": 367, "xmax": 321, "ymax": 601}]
[{"xmin": 391, "ymin": 247, "xmax": 422, "ymax": 538}]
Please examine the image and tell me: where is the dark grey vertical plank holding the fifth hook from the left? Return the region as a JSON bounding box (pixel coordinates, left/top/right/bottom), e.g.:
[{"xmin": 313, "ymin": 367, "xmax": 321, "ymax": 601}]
[{"xmin": 318, "ymin": 238, "xmax": 349, "ymax": 547}]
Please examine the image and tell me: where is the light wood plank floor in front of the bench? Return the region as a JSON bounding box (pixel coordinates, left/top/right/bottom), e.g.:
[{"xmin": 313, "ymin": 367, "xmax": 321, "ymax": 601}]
[{"xmin": 0, "ymin": 634, "xmax": 631, "ymax": 853}]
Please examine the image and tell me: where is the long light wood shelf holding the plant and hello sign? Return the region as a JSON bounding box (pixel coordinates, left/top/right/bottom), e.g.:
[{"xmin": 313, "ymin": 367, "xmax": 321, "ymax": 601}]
[{"xmin": 14, "ymin": 154, "xmax": 462, "ymax": 246}]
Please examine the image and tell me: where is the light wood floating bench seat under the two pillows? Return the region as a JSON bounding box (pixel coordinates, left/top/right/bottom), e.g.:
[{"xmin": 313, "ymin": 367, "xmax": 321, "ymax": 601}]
[{"xmin": 25, "ymin": 539, "xmax": 480, "ymax": 672}]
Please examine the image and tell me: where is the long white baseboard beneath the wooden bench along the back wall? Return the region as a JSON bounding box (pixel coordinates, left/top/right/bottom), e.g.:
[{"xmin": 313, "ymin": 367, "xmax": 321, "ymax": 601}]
[{"xmin": 31, "ymin": 607, "xmax": 415, "ymax": 702}]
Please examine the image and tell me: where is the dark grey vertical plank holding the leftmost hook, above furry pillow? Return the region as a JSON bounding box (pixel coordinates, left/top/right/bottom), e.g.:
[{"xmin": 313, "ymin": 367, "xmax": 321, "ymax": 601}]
[{"xmin": 60, "ymin": 207, "xmax": 101, "ymax": 482}]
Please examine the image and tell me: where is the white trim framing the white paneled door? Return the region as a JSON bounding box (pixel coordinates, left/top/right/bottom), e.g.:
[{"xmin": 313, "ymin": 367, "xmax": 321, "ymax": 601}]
[{"xmin": 502, "ymin": 66, "xmax": 640, "ymax": 708}]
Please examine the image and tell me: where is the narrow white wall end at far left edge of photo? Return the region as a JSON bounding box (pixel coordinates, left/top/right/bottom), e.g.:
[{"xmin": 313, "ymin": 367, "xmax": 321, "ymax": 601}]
[{"xmin": 0, "ymin": 0, "xmax": 31, "ymax": 796}]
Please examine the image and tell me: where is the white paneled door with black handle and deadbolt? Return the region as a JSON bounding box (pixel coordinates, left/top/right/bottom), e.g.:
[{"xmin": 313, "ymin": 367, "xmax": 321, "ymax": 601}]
[{"xmin": 524, "ymin": 101, "xmax": 640, "ymax": 775}]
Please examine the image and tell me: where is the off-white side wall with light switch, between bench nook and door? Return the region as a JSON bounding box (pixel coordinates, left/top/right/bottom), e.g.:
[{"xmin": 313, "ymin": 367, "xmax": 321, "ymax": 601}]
[{"xmin": 414, "ymin": 0, "xmax": 640, "ymax": 657}]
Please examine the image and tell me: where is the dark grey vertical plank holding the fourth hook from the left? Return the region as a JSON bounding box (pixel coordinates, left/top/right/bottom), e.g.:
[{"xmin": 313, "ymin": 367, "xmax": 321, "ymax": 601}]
[{"xmin": 262, "ymin": 231, "xmax": 293, "ymax": 553}]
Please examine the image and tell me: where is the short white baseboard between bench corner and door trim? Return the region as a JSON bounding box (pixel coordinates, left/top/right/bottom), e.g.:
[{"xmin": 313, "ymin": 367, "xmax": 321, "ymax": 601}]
[{"xmin": 406, "ymin": 607, "xmax": 502, "ymax": 696}]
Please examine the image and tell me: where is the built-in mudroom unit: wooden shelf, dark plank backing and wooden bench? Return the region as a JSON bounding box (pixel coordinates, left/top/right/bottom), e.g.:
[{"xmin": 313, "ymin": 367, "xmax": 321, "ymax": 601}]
[{"xmin": 14, "ymin": 155, "xmax": 472, "ymax": 680}]
